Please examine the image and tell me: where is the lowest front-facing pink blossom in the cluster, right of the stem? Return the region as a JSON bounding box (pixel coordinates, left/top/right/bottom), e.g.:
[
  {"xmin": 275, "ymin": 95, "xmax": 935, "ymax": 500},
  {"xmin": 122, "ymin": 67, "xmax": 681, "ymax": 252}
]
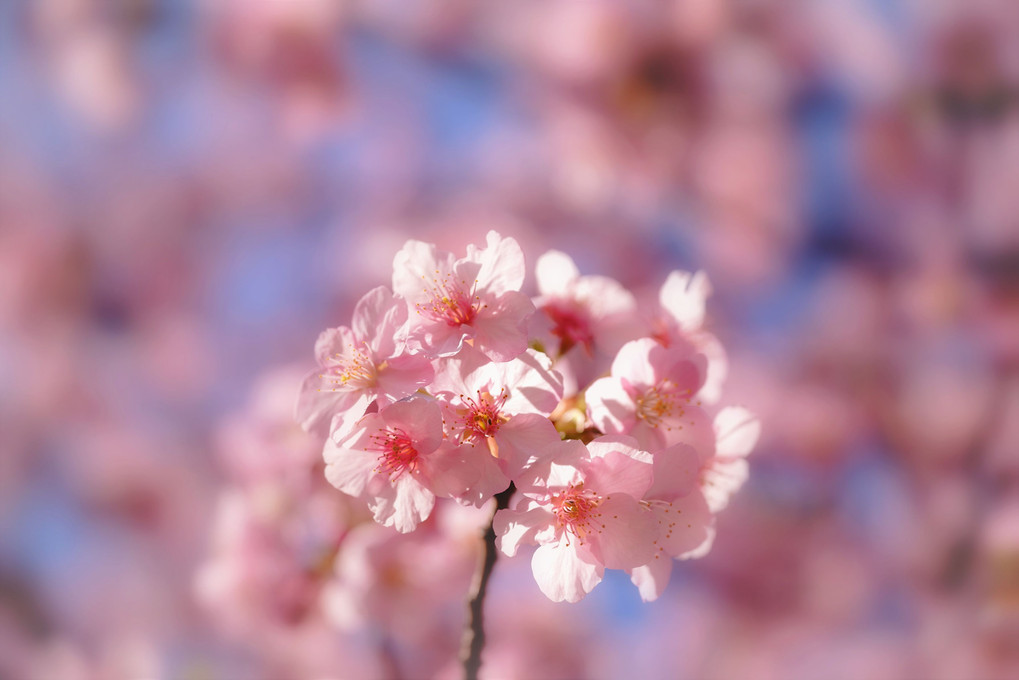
[{"xmin": 493, "ymin": 436, "xmax": 658, "ymax": 603}]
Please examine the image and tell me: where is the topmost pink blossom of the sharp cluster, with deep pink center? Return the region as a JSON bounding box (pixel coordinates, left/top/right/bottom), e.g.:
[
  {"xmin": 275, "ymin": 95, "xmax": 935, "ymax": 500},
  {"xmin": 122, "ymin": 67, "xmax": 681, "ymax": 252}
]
[{"xmin": 392, "ymin": 231, "xmax": 534, "ymax": 361}]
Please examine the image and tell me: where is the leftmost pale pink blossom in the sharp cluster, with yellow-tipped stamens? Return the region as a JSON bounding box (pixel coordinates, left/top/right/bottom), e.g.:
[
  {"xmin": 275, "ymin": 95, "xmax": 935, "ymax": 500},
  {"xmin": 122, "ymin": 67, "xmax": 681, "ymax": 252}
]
[{"xmin": 297, "ymin": 286, "xmax": 433, "ymax": 430}]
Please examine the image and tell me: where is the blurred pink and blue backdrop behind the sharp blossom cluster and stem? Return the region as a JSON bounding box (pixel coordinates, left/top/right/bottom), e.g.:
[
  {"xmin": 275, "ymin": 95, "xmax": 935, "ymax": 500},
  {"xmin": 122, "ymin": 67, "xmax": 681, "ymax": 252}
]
[{"xmin": 0, "ymin": 0, "xmax": 1019, "ymax": 680}]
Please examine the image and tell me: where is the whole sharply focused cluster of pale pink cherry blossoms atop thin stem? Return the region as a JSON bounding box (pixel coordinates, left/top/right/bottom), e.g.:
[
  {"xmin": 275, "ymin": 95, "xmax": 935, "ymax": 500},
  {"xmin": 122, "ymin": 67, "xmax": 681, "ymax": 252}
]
[{"xmin": 297, "ymin": 231, "xmax": 759, "ymax": 601}]
